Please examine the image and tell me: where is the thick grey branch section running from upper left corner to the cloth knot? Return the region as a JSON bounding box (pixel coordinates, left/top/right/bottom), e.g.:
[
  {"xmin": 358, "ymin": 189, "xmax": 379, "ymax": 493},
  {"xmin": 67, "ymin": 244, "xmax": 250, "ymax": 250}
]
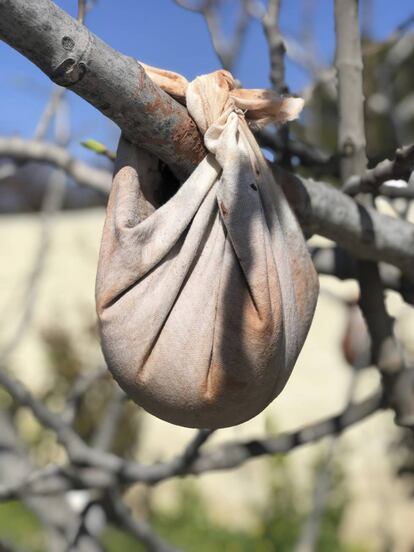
[{"xmin": 0, "ymin": 0, "xmax": 205, "ymax": 177}]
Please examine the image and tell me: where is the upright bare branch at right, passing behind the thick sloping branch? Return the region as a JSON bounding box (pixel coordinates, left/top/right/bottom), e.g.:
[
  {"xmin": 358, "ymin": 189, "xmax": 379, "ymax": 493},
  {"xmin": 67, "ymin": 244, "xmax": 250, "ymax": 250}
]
[{"xmin": 335, "ymin": 0, "xmax": 414, "ymax": 427}]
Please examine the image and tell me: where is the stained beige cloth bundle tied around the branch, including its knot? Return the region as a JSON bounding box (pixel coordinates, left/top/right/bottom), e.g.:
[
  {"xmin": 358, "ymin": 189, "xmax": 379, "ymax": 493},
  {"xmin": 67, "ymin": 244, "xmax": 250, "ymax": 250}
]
[{"xmin": 96, "ymin": 67, "xmax": 318, "ymax": 428}]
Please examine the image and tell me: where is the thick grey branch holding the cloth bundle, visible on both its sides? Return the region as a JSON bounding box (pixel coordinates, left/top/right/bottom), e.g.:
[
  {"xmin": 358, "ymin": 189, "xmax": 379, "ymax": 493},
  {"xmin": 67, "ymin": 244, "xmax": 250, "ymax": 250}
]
[{"xmin": 0, "ymin": 0, "xmax": 414, "ymax": 277}]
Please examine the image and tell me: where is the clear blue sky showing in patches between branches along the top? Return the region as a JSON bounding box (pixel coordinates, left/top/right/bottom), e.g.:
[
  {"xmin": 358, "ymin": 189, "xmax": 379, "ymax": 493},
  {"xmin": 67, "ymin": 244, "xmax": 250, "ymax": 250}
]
[{"xmin": 0, "ymin": 0, "xmax": 414, "ymax": 159}]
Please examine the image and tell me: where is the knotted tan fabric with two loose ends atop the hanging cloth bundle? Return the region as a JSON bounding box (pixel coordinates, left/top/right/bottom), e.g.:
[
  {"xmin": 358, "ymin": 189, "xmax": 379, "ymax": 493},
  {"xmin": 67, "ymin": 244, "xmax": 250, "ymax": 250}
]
[{"xmin": 141, "ymin": 63, "xmax": 304, "ymax": 134}]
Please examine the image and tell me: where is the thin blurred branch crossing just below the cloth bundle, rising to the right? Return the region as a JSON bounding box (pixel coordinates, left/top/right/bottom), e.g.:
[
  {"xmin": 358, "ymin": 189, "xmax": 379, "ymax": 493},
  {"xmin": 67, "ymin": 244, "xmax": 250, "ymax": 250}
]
[{"xmin": 0, "ymin": 388, "xmax": 383, "ymax": 501}]
